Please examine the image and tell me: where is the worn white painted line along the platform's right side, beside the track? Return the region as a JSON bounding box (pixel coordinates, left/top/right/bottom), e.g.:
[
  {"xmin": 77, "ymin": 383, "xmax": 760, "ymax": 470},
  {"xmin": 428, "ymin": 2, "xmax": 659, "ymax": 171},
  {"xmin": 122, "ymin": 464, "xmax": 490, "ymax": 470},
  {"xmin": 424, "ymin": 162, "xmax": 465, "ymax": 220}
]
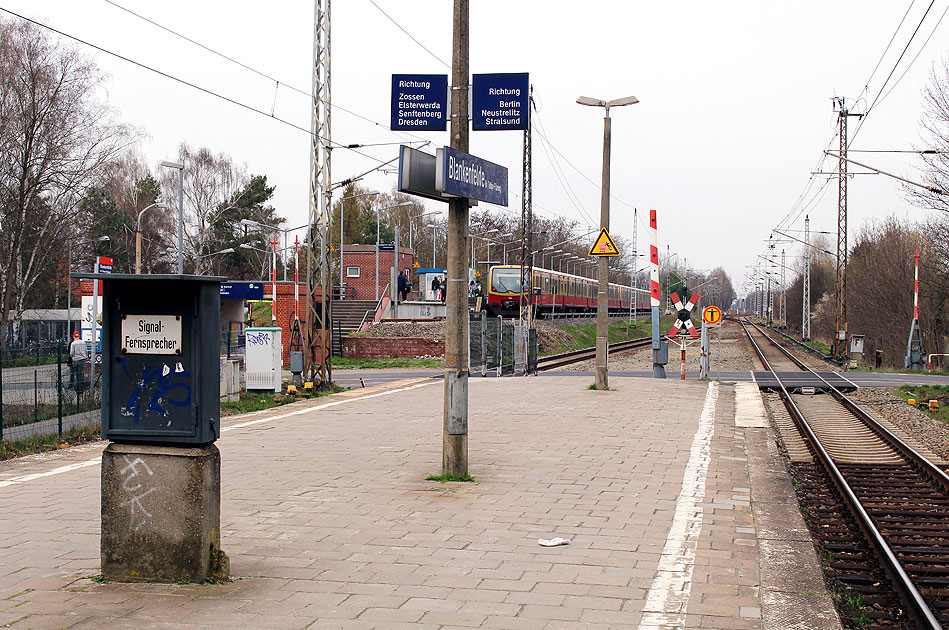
[{"xmin": 639, "ymin": 382, "xmax": 718, "ymax": 630}]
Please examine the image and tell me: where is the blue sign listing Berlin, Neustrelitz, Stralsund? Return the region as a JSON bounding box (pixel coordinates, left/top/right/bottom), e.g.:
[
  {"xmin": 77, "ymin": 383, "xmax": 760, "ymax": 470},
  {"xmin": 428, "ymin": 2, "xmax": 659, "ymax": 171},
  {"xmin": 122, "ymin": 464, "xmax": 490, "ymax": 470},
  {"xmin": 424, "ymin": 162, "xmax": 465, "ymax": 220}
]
[{"xmin": 471, "ymin": 72, "xmax": 530, "ymax": 131}]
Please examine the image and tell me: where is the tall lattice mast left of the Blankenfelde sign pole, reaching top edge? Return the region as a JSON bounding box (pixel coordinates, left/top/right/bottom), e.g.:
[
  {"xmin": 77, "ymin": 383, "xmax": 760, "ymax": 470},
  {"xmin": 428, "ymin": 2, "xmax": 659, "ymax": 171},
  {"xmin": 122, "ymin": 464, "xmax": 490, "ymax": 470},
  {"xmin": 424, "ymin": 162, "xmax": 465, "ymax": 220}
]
[{"xmin": 306, "ymin": 0, "xmax": 333, "ymax": 387}]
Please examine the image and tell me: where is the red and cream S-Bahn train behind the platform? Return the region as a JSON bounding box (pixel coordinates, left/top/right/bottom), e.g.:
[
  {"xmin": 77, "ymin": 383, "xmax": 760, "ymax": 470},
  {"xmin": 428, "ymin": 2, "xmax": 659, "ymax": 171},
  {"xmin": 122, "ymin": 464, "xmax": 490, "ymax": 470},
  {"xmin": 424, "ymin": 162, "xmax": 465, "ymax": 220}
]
[{"xmin": 486, "ymin": 265, "xmax": 650, "ymax": 317}]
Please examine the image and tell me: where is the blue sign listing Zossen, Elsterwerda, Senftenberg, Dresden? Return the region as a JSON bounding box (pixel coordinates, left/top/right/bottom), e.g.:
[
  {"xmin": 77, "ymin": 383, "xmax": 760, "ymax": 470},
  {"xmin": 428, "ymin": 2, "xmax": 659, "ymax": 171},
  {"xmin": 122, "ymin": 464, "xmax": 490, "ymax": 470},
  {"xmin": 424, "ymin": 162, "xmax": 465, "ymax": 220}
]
[{"xmin": 389, "ymin": 74, "xmax": 448, "ymax": 131}]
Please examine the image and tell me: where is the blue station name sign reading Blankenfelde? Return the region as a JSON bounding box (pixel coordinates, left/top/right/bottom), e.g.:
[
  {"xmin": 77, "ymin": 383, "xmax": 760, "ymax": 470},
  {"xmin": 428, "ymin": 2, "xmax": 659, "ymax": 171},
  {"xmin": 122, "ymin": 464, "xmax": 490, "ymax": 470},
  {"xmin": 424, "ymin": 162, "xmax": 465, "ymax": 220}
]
[{"xmin": 435, "ymin": 147, "xmax": 507, "ymax": 206}]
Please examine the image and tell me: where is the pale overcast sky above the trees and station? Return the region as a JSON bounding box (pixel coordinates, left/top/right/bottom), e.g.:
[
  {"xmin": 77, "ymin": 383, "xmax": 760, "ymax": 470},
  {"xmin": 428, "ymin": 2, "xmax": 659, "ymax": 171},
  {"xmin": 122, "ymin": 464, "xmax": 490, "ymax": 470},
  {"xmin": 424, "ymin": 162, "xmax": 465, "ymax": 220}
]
[{"xmin": 0, "ymin": 0, "xmax": 949, "ymax": 288}]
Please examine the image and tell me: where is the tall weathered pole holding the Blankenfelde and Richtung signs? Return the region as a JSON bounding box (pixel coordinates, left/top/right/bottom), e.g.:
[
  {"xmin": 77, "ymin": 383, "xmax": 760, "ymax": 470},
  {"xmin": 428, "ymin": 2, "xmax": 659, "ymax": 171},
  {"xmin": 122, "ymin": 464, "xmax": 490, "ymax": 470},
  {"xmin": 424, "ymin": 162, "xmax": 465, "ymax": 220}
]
[{"xmin": 442, "ymin": 0, "xmax": 468, "ymax": 477}]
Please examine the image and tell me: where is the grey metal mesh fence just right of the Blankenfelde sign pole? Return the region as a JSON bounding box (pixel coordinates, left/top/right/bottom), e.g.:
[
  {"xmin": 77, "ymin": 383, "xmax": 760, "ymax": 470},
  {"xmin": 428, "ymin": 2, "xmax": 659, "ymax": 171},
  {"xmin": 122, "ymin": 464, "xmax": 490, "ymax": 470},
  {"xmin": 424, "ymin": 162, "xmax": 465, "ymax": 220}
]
[{"xmin": 468, "ymin": 311, "xmax": 537, "ymax": 376}]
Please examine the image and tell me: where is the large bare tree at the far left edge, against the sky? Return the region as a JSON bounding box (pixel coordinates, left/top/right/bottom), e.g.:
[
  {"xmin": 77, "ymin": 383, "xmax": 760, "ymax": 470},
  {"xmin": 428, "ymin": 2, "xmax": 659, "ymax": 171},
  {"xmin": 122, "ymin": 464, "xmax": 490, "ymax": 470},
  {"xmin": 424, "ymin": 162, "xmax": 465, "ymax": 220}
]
[{"xmin": 0, "ymin": 21, "xmax": 133, "ymax": 350}]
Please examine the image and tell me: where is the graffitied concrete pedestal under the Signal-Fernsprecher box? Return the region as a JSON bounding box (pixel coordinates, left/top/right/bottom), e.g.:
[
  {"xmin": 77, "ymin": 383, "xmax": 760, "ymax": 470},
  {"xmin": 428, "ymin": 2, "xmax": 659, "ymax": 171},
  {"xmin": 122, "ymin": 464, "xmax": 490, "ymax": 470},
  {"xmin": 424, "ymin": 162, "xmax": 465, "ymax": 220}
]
[{"xmin": 101, "ymin": 443, "xmax": 230, "ymax": 582}]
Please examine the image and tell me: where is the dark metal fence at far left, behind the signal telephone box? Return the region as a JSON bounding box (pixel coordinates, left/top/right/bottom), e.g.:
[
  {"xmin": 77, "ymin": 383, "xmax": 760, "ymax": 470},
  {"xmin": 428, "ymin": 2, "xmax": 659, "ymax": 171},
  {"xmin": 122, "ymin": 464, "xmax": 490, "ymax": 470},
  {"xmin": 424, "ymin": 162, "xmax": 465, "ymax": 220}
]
[{"xmin": 0, "ymin": 344, "xmax": 101, "ymax": 441}]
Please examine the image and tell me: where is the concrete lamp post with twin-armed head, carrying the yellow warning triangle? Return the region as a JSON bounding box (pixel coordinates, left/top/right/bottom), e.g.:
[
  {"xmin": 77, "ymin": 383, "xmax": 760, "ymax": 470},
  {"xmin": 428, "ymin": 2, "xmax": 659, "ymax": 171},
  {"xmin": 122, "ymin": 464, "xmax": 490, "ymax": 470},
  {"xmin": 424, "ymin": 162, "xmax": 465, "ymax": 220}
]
[{"xmin": 577, "ymin": 96, "xmax": 639, "ymax": 389}]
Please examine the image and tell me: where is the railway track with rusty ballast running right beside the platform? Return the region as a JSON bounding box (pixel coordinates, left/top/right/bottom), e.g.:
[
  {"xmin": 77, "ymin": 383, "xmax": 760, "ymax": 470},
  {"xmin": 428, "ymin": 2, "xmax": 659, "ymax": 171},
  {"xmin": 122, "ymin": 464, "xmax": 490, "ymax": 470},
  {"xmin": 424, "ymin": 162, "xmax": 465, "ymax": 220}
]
[{"xmin": 742, "ymin": 322, "xmax": 949, "ymax": 629}]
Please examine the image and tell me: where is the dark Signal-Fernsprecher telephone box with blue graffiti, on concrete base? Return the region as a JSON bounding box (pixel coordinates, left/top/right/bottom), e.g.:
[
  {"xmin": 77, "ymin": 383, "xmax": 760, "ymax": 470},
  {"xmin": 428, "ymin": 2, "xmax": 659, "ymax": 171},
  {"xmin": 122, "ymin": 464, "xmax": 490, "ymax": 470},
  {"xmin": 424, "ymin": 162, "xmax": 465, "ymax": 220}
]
[{"xmin": 99, "ymin": 274, "xmax": 223, "ymax": 446}]
